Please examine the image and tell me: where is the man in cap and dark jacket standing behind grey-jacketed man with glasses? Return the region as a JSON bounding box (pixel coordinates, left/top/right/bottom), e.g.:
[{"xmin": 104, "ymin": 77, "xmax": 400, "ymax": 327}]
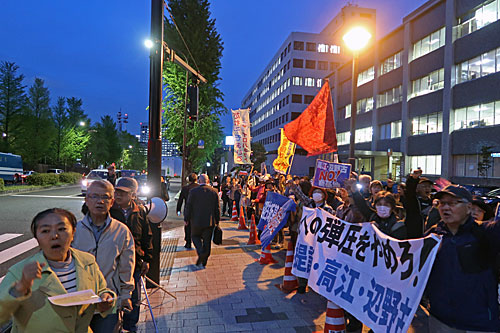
[{"xmin": 110, "ymin": 177, "xmax": 153, "ymax": 332}]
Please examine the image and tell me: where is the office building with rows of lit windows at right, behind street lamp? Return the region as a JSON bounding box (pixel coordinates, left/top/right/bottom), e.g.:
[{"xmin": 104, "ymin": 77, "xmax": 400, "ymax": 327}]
[{"xmin": 323, "ymin": 0, "xmax": 500, "ymax": 186}]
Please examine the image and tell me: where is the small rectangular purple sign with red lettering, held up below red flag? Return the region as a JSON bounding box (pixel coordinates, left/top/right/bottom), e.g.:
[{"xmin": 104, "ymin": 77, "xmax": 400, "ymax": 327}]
[{"xmin": 313, "ymin": 160, "xmax": 351, "ymax": 188}]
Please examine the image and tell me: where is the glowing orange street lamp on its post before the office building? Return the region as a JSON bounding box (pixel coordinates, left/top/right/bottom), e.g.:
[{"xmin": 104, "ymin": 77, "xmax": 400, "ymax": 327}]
[{"xmin": 342, "ymin": 26, "xmax": 372, "ymax": 171}]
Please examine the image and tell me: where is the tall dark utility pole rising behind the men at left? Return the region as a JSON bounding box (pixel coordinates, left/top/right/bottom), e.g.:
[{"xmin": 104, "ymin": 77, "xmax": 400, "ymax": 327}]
[{"xmin": 148, "ymin": 0, "xmax": 164, "ymax": 283}]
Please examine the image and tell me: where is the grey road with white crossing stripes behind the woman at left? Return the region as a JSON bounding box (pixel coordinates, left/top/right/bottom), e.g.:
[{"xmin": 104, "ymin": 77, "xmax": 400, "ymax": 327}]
[{"xmin": 0, "ymin": 180, "xmax": 183, "ymax": 280}]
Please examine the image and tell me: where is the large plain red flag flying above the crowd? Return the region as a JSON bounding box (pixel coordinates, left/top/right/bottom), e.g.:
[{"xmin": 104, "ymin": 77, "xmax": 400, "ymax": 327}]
[{"xmin": 285, "ymin": 80, "xmax": 337, "ymax": 156}]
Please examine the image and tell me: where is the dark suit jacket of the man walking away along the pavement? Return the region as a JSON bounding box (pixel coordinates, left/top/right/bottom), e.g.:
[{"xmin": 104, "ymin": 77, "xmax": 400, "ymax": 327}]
[{"xmin": 184, "ymin": 185, "xmax": 220, "ymax": 228}]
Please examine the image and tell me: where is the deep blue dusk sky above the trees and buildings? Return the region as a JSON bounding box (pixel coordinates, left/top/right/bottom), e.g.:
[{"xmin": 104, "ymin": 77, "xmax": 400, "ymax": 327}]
[{"xmin": 0, "ymin": 0, "xmax": 425, "ymax": 135}]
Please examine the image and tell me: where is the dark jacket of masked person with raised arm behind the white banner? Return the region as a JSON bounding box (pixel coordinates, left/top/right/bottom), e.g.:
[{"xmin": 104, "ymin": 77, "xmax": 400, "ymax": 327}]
[{"xmin": 352, "ymin": 192, "xmax": 407, "ymax": 239}]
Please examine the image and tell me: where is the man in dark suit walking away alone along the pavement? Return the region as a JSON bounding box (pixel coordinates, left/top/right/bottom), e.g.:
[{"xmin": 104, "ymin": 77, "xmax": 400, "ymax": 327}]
[{"xmin": 184, "ymin": 174, "xmax": 220, "ymax": 267}]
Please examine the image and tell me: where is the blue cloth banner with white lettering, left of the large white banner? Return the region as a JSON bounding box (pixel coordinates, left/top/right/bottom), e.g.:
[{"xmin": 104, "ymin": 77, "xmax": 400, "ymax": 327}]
[{"xmin": 257, "ymin": 192, "xmax": 296, "ymax": 249}]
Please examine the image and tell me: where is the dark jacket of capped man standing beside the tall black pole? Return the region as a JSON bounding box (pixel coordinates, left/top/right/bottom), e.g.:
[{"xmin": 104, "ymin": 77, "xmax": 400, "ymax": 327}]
[{"xmin": 109, "ymin": 201, "xmax": 153, "ymax": 269}]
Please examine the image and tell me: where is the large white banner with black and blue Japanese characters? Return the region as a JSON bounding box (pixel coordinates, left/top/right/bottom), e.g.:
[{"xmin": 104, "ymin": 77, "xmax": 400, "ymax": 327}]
[{"xmin": 292, "ymin": 208, "xmax": 441, "ymax": 332}]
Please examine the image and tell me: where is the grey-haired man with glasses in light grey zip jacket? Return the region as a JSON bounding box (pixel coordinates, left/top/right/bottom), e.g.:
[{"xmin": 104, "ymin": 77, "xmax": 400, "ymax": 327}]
[{"xmin": 73, "ymin": 180, "xmax": 135, "ymax": 333}]
